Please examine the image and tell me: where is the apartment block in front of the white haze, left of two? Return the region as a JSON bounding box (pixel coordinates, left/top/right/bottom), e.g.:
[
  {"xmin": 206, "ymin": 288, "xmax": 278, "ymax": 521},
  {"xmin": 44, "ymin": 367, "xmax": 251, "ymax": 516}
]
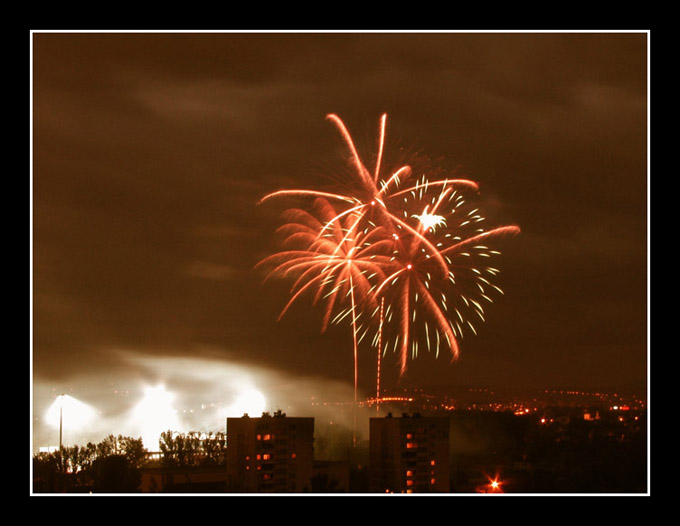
[{"xmin": 227, "ymin": 411, "xmax": 314, "ymax": 493}]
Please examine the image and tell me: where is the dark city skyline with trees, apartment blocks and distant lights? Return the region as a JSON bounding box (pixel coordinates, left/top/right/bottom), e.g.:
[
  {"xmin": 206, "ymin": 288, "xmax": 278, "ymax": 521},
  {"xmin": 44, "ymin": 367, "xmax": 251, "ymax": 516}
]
[{"xmin": 33, "ymin": 393, "xmax": 649, "ymax": 494}]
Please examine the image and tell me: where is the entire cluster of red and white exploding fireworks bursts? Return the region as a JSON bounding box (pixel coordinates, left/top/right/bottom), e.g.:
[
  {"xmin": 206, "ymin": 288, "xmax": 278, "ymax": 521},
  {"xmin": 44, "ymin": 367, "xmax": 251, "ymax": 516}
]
[{"xmin": 260, "ymin": 114, "xmax": 519, "ymax": 384}]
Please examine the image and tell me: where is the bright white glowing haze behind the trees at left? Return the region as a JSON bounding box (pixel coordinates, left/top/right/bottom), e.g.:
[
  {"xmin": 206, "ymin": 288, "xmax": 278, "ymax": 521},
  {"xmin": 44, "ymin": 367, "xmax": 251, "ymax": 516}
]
[{"xmin": 33, "ymin": 353, "xmax": 352, "ymax": 452}]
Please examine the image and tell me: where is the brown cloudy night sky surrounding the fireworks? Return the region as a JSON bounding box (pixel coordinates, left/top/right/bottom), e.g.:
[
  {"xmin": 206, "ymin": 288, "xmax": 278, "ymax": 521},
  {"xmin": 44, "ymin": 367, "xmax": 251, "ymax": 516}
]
[{"xmin": 31, "ymin": 32, "xmax": 648, "ymax": 450}]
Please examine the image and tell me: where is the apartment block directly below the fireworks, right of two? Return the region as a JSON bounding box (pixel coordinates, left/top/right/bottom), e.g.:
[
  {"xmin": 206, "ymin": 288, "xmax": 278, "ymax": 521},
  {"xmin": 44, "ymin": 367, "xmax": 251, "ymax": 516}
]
[{"xmin": 369, "ymin": 414, "xmax": 450, "ymax": 493}]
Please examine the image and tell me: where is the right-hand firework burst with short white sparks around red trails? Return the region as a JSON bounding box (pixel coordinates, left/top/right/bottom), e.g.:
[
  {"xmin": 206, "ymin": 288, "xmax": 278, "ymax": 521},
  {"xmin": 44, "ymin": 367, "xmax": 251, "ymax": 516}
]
[{"xmin": 373, "ymin": 178, "xmax": 519, "ymax": 374}]
